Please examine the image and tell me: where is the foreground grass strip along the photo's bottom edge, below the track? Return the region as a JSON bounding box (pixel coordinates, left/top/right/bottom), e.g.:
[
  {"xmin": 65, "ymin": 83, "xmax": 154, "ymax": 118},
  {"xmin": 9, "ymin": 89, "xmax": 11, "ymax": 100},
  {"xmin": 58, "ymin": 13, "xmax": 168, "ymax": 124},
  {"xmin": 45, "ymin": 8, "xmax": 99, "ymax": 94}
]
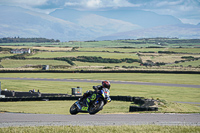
[{"xmin": 0, "ymin": 125, "xmax": 200, "ymax": 133}]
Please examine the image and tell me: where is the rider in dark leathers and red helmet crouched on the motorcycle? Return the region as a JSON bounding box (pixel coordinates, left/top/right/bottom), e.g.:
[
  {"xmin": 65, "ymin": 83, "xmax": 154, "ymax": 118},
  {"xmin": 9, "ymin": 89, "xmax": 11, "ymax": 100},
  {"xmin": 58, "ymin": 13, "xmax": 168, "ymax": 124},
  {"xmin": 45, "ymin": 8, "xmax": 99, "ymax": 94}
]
[{"xmin": 81, "ymin": 80, "xmax": 111, "ymax": 111}]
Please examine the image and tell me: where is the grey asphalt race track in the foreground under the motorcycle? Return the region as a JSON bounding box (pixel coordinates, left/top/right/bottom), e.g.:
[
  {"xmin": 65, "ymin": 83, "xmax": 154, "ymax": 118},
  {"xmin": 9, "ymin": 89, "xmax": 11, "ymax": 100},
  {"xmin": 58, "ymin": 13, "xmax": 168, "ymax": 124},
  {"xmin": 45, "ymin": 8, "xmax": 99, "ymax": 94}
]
[{"xmin": 0, "ymin": 113, "xmax": 200, "ymax": 128}]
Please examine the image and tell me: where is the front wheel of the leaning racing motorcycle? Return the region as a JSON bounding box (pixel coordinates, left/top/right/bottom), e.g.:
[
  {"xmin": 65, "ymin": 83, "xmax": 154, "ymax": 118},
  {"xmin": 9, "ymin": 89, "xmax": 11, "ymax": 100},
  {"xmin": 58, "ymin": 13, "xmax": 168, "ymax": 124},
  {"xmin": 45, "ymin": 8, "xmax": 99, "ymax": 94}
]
[{"xmin": 88, "ymin": 100, "xmax": 104, "ymax": 115}]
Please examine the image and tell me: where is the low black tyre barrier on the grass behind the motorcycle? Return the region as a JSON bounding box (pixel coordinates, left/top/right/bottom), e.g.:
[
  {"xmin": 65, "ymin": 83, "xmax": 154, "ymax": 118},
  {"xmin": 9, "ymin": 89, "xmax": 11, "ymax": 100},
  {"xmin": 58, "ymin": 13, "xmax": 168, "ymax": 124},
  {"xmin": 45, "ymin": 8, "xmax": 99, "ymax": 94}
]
[{"xmin": 0, "ymin": 91, "xmax": 158, "ymax": 112}]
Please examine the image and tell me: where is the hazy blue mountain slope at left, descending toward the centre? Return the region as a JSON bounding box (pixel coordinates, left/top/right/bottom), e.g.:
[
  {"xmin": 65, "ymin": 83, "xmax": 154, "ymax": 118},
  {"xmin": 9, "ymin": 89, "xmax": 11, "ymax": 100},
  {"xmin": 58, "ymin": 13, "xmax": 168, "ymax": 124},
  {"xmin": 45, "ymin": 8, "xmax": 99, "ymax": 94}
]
[{"xmin": 0, "ymin": 6, "xmax": 96, "ymax": 41}]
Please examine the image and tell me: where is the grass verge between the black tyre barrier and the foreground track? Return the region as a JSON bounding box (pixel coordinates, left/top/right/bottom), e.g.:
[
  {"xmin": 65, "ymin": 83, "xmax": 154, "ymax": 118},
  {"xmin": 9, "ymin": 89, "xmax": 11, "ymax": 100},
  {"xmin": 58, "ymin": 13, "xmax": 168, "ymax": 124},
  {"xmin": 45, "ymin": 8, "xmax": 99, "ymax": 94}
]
[{"xmin": 0, "ymin": 101, "xmax": 200, "ymax": 115}]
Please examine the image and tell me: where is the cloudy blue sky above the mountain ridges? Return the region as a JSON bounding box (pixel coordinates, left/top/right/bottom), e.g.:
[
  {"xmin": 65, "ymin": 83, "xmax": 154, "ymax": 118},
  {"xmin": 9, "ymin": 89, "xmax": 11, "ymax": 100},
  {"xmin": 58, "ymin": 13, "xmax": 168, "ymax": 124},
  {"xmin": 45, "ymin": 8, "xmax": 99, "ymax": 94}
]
[{"xmin": 0, "ymin": 0, "xmax": 200, "ymax": 25}]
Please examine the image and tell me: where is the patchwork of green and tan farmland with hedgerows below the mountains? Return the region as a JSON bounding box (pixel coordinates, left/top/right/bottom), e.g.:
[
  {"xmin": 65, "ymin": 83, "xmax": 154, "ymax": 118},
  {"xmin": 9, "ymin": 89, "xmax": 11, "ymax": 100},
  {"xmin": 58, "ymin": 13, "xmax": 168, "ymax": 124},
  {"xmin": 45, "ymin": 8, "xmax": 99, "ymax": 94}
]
[{"xmin": 0, "ymin": 38, "xmax": 200, "ymax": 71}]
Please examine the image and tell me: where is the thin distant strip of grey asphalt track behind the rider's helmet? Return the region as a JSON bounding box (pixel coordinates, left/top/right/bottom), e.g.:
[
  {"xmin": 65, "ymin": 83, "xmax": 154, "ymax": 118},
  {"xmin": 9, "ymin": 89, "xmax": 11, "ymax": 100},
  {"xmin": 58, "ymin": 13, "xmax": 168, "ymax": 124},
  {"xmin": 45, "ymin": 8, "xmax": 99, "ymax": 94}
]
[{"xmin": 0, "ymin": 78, "xmax": 200, "ymax": 88}]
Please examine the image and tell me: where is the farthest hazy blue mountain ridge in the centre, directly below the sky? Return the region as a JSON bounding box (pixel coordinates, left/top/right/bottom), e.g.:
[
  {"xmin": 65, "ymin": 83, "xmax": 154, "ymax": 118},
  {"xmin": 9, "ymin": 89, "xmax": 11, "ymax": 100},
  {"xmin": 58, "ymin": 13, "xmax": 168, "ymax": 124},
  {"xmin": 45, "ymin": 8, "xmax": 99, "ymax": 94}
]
[{"xmin": 50, "ymin": 8, "xmax": 182, "ymax": 28}]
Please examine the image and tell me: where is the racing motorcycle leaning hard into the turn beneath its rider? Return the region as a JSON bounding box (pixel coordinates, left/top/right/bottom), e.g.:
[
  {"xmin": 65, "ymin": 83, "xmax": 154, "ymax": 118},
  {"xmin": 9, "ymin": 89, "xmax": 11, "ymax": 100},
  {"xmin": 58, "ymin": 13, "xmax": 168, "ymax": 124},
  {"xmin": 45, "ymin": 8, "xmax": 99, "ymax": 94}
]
[{"xmin": 69, "ymin": 88, "xmax": 111, "ymax": 115}]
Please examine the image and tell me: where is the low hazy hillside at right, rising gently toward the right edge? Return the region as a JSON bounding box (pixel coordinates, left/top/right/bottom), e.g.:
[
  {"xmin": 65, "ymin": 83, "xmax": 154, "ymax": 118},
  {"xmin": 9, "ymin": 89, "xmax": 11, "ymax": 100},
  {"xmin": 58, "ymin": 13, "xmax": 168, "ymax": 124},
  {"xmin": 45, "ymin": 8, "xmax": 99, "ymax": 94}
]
[{"xmin": 96, "ymin": 24, "xmax": 200, "ymax": 40}]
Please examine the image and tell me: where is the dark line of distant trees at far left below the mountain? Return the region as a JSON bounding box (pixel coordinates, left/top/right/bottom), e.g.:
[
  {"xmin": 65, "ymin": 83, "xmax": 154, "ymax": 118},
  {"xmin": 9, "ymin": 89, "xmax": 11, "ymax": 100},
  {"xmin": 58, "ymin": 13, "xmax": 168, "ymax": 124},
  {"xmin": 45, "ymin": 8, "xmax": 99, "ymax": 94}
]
[{"xmin": 0, "ymin": 37, "xmax": 60, "ymax": 43}]
